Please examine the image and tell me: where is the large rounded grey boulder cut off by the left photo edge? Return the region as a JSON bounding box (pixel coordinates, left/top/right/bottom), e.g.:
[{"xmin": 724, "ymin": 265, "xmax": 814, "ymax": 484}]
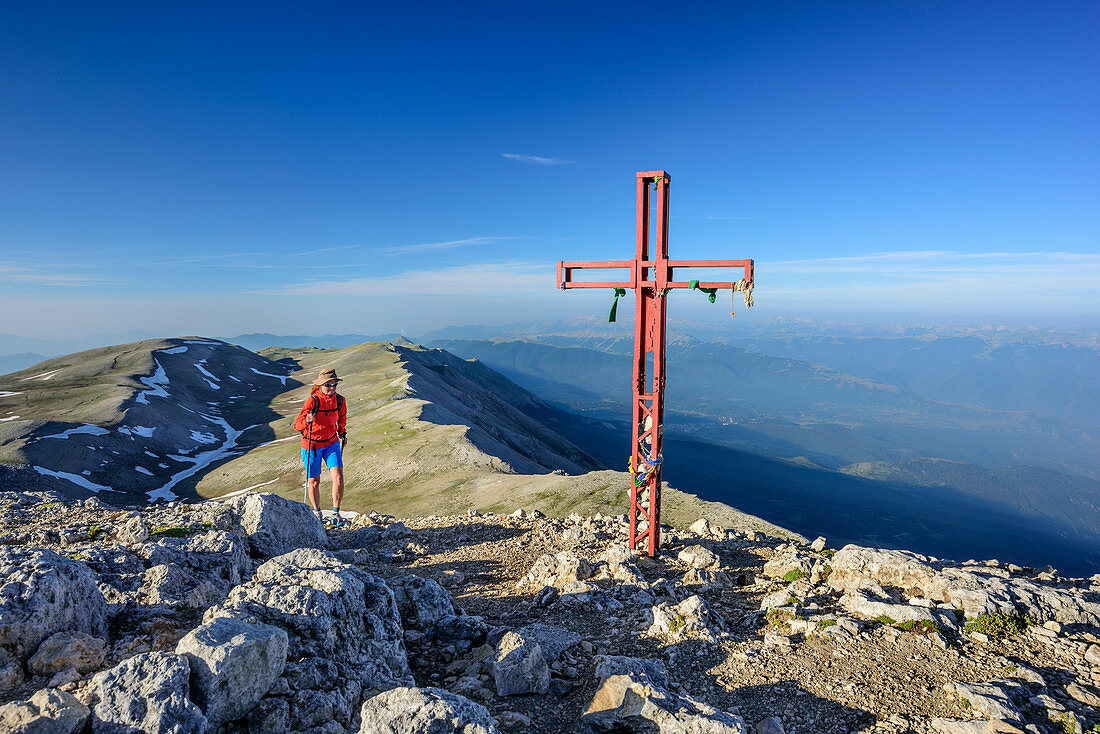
[{"xmin": 0, "ymin": 546, "xmax": 107, "ymax": 660}]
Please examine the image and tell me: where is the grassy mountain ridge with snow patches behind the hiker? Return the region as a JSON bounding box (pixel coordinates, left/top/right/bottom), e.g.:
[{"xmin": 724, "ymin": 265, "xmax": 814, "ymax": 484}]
[{"xmin": 0, "ymin": 337, "xmax": 798, "ymax": 537}]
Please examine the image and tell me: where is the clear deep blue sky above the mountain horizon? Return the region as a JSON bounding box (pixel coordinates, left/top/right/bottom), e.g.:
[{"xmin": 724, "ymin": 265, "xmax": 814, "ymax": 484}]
[{"xmin": 0, "ymin": 2, "xmax": 1100, "ymax": 337}]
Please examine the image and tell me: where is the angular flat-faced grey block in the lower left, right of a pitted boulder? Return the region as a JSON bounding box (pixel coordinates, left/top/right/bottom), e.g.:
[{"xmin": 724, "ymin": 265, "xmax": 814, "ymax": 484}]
[{"xmin": 176, "ymin": 617, "xmax": 287, "ymax": 728}]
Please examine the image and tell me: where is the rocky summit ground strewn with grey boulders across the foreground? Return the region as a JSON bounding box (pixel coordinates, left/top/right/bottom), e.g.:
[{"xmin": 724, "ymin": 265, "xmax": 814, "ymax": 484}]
[{"xmin": 0, "ymin": 492, "xmax": 1100, "ymax": 734}]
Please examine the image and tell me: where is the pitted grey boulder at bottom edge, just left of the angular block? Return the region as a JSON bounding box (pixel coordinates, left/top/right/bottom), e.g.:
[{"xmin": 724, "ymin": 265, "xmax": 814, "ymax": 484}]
[{"xmin": 91, "ymin": 653, "xmax": 207, "ymax": 734}]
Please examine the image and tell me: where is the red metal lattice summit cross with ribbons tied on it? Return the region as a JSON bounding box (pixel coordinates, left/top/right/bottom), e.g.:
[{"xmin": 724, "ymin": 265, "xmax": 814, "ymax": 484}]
[{"xmin": 558, "ymin": 171, "xmax": 752, "ymax": 556}]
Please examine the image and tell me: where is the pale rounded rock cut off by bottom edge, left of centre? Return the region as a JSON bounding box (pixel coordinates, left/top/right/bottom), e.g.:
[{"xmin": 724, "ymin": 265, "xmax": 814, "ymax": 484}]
[{"xmin": 359, "ymin": 687, "xmax": 498, "ymax": 734}]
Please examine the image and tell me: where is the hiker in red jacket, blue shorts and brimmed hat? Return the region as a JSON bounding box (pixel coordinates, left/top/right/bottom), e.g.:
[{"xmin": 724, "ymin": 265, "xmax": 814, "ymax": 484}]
[{"xmin": 294, "ymin": 369, "xmax": 348, "ymax": 527}]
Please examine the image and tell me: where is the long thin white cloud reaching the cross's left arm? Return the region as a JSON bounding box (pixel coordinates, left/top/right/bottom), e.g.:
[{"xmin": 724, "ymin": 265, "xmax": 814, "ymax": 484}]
[{"xmin": 252, "ymin": 261, "xmax": 556, "ymax": 298}]
